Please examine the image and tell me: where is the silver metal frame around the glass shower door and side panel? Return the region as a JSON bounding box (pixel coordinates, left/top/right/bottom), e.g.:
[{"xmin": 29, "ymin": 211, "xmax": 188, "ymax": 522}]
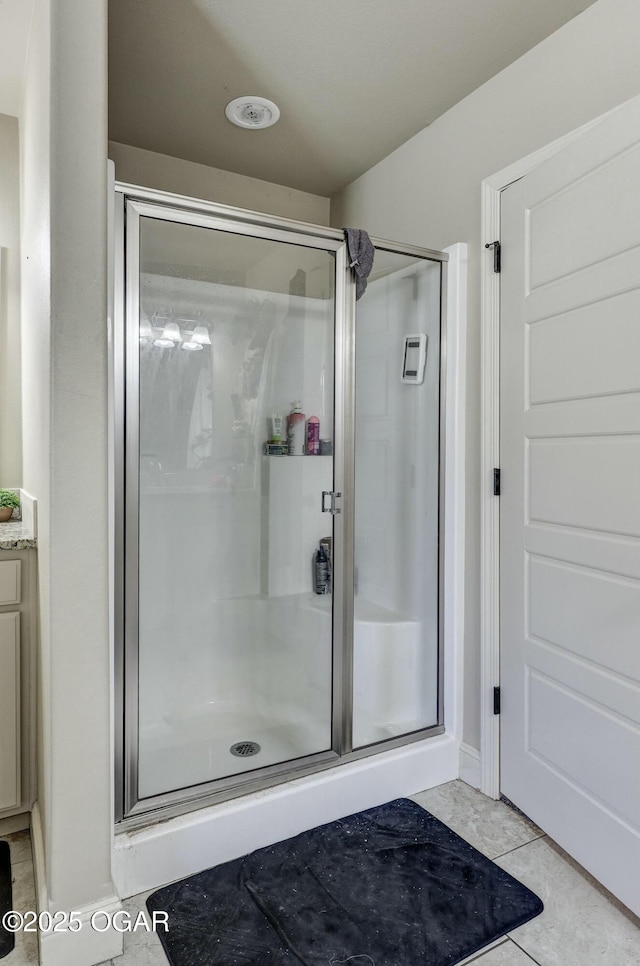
[{"xmin": 113, "ymin": 183, "xmax": 448, "ymax": 828}]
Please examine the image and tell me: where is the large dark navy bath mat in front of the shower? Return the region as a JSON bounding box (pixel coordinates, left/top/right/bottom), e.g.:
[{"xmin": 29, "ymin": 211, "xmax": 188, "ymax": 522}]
[{"xmin": 147, "ymin": 798, "xmax": 543, "ymax": 966}]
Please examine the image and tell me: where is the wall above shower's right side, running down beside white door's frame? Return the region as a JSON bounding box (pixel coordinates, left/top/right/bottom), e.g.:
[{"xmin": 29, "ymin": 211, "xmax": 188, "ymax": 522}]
[{"xmin": 331, "ymin": 0, "xmax": 640, "ymax": 748}]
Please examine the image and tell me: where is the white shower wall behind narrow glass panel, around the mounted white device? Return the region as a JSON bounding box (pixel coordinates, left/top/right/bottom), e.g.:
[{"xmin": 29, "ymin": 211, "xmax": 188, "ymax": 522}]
[{"xmin": 355, "ymin": 262, "xmax": 440, "ymax": 628}]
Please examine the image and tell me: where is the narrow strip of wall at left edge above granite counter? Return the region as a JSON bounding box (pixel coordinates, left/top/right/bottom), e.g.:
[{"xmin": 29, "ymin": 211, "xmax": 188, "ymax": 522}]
[{"xmin": 0, "ymin": 114, "xmax": 22, "ymax": 486}]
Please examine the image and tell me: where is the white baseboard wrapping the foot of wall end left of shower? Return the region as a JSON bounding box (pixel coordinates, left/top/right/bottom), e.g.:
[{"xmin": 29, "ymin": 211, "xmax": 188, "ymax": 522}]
[{"xmin": 31, "ymin": 802, "xmax": 122, "ymax": 966}]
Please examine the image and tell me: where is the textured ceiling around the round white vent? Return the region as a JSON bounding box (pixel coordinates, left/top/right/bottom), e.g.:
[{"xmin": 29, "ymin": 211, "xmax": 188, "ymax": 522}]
[{"xmin": 109, "ymin": 0, "xmax": 593, "ymax": 196}]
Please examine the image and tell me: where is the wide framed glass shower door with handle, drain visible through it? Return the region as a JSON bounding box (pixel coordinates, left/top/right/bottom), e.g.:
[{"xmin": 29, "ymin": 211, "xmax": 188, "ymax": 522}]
[{"xmin": 126, "ymin": 202, "xmax": 340, "ymax": 802}]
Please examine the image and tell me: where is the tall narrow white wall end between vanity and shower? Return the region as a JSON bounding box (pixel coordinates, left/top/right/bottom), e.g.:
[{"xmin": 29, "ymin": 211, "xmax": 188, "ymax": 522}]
[{"xmin": 50, "ymin": 0, "xmax": 112, "ymax": 906}]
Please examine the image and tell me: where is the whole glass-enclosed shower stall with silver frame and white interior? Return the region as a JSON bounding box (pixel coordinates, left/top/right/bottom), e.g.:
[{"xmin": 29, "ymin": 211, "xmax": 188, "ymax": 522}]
[{"xmin": 113, "ymin": 185, "xmax": 447, "ymax": 828}]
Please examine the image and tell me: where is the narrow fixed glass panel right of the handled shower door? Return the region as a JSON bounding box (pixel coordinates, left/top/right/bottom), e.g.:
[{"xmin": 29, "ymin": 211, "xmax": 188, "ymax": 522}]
[{"xmin": 353, "ymin": 247, "xmax": 442, "ymax": 749}]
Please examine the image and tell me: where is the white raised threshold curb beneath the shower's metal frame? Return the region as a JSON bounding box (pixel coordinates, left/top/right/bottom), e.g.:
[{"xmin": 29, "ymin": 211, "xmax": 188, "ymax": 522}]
[{"xmin": 113, "ymin": 734, "xmax": 459, "ymax": 899}]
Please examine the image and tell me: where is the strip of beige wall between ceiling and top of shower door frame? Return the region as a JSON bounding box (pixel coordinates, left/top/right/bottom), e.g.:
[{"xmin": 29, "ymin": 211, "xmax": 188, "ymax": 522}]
[{"xmin": 109, "ymin": 141, "xmax": 329, "ymax": 225}]
